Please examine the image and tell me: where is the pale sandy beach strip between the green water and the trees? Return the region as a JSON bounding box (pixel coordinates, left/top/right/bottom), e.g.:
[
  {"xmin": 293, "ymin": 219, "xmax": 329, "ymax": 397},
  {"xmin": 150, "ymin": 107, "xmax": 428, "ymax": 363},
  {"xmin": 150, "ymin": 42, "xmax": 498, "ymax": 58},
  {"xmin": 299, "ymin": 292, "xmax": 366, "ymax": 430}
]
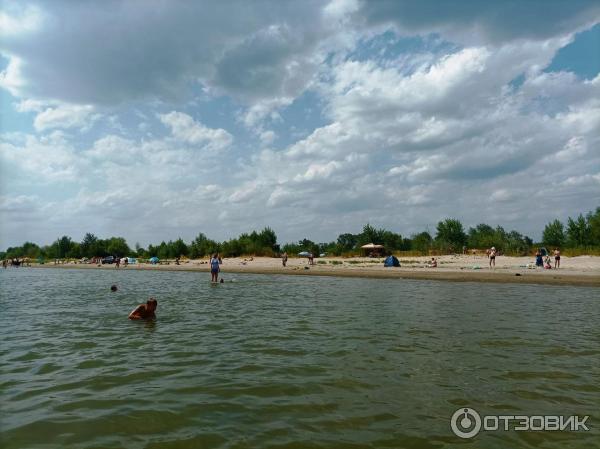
[{"xmin": 32, "ymin": 255, "xmax": 600, "ymax": 287}]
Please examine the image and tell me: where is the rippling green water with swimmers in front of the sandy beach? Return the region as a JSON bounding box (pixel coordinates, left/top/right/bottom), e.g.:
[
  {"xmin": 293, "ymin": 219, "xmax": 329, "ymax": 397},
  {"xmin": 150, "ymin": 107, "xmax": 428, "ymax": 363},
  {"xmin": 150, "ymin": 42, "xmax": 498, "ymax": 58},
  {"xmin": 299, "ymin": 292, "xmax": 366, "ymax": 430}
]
[{"xmin": 0, "ymin": 268, "xmax": 600, "ymax": 449}]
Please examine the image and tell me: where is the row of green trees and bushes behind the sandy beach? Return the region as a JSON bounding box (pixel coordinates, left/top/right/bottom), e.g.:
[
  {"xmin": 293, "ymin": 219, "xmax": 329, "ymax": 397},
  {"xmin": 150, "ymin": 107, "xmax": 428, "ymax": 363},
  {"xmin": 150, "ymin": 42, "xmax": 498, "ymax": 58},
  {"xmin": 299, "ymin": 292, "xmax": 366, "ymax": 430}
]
[{"xmin": 0, "ymin": 207, "xmax": 600, "ymax": 259}]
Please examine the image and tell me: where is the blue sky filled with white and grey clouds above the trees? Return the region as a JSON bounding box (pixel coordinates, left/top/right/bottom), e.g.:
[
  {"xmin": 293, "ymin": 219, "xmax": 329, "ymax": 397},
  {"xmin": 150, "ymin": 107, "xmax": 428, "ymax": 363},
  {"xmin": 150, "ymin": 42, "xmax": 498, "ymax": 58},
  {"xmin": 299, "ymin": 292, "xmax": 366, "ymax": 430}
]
[{"xmin": 0, "ymin": 0, "xmax": 600, "ymax": 249}]
